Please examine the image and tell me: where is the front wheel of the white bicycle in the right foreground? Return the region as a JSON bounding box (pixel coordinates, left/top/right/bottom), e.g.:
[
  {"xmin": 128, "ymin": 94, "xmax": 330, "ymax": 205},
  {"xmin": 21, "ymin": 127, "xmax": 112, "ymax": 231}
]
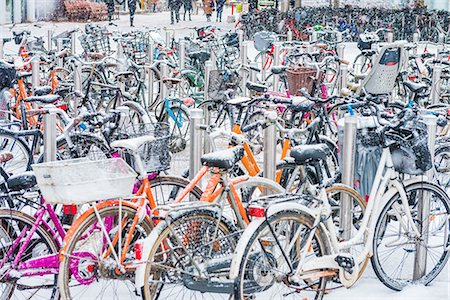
[{"xmin": 372, "ymin": 182, "xmax": 450, "ymax": 291}]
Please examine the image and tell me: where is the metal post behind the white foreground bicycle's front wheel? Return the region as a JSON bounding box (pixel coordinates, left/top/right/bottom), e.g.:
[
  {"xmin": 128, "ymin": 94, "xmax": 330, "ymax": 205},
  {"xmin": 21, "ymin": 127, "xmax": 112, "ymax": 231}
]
[{"xmin": 413, "ymin": 115, "xmax": 437, "ymax": 280}]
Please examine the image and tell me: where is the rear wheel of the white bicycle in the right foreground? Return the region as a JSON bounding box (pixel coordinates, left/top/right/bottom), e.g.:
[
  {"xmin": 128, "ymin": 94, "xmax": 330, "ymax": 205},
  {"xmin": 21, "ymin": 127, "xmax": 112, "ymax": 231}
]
[{"xmin": 234, "ymin": 210, "xmax": 329, "ymax": 300}]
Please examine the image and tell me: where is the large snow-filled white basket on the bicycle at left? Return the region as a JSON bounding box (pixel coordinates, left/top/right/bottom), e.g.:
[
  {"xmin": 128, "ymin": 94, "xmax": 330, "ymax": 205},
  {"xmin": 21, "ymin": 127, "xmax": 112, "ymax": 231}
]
[{"xmin": 33, "ymin": 158, "xmax": 137, "ymax": 204}]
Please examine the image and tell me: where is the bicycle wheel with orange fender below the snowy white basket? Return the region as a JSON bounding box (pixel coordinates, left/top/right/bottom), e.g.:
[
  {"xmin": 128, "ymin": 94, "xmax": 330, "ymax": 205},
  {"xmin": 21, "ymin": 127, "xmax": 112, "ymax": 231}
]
[{"xmin": 58, "ymin": 202, "xmax": 153, "ymax": 299}]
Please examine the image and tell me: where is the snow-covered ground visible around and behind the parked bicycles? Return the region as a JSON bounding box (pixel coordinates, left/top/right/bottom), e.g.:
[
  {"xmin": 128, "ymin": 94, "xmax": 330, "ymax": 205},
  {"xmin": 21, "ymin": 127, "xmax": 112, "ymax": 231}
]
[{"xmin": 0, "ymin": 8, "xmax": 450, "ymax": 300}]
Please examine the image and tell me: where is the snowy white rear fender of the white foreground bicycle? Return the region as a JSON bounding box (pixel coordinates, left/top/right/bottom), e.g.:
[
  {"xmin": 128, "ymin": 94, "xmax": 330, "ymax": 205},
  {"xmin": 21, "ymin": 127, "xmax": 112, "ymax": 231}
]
[{"xmin": 229, "ymin": 202, "xmax": 316, "ymax": 280}]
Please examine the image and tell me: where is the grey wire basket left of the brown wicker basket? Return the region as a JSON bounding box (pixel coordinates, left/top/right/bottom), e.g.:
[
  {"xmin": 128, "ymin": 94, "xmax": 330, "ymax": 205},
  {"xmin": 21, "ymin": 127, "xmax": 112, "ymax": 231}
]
[{"xmin": 208, "ymin": 70, "xmax": 240, "ymax": 101}]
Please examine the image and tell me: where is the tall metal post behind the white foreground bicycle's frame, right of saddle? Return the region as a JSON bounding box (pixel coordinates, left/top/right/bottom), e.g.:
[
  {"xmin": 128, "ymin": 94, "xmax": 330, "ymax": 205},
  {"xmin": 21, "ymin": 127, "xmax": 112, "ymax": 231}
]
[{"xmin": 339, "ymin": 116, "xmax": 358, "ymax": 241}]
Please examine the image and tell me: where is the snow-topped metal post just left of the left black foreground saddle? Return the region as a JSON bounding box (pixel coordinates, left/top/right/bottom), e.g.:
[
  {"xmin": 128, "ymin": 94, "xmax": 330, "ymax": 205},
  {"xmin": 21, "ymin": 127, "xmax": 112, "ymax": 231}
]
[{"xmin": 189, "ymin": 108, "xmax": 203, "ymax": 179}]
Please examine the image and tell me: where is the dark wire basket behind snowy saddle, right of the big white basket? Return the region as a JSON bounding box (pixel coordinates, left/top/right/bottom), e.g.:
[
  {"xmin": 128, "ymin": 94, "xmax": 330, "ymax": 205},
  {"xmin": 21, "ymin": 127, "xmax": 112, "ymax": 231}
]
[{"xmin": 120, "ymin": 123, "xmax": 171, "ymax": 173}]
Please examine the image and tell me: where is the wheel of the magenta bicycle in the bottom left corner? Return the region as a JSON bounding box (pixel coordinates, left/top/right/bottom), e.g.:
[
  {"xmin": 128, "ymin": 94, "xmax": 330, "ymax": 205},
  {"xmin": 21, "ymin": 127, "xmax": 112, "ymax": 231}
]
[{"xmin": 0, "ymin": 209, "xmax": 59, "ymax": 299}]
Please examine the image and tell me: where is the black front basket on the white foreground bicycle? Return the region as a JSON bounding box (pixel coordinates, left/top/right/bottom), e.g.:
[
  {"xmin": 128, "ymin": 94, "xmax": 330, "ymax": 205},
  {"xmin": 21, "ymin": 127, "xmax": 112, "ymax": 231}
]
[{"xmin": 386, "ymin": 123, "xmax": 432, "ymax": 175}]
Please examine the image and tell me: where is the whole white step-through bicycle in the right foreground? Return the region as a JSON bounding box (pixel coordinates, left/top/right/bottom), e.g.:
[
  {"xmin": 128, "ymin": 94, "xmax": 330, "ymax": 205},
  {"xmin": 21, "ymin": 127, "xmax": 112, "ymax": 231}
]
[{"xmin": 230, "ymin": 106, "xmax": 450, "ymax": 299}]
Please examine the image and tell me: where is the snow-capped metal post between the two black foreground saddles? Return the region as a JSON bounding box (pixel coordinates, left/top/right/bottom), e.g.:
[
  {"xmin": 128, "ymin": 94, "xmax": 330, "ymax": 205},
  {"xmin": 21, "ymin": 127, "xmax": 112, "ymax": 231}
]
[{"xmin": 263, "ymin": 111, "xmax": 277, "ymax": 180}]
